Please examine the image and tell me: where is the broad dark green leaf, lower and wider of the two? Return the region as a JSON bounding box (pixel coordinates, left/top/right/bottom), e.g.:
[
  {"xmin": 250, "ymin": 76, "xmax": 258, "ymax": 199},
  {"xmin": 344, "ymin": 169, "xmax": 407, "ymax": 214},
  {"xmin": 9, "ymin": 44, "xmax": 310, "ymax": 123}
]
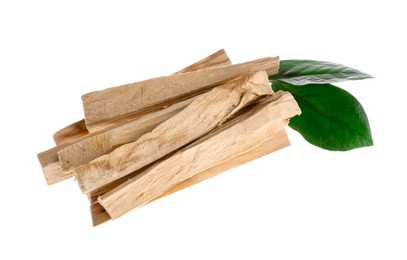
[{"xmin": 272, "ymin": 81, "xmax": 373, "ymax": 151}]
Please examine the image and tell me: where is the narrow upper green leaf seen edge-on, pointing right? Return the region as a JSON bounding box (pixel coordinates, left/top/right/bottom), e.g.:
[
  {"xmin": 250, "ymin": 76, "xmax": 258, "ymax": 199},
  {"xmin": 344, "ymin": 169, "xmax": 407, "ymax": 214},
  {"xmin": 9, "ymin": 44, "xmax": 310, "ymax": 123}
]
[{"xmin": 269, "ymin": 60, "xmax": 372, "ymax": 86}]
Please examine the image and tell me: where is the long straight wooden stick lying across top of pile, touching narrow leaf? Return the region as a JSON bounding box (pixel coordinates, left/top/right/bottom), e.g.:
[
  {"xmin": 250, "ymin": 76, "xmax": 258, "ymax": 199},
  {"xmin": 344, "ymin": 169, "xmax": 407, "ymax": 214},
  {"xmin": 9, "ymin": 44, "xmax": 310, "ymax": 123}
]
[{"xmin": 82, "ymin": 57, "xmax": 279, "ymax": 131}]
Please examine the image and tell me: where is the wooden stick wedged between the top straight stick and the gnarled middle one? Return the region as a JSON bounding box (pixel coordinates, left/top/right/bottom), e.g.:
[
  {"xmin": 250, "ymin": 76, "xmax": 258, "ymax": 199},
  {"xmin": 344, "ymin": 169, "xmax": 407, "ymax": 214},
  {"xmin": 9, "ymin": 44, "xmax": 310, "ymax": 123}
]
[{"xmin": 58, "ymin": 96, "xmax": 199, "ymax": 170}]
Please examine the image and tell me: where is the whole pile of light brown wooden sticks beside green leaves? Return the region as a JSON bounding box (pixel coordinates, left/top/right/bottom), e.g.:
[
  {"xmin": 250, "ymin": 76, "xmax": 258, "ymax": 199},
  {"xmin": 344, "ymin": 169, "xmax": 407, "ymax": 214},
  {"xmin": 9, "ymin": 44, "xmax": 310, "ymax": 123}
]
[{"xmin": 38, "ymin": 50, "xmax": 300, "ymax": 225}]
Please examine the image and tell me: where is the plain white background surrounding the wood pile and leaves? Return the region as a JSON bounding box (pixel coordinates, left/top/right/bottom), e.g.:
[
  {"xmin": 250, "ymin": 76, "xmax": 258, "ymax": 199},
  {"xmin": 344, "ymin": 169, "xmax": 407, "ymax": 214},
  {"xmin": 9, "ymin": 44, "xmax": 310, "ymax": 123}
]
[{"xmin": 0, "ymin": 0, "xmax": 407, "ymax": 260}]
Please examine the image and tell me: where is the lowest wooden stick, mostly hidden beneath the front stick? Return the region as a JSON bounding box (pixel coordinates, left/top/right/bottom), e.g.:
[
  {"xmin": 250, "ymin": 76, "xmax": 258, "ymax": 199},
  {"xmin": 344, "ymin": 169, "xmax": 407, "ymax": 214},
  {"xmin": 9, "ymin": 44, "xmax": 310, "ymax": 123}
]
[{"xmin": 90, "ymin": 129, "xmax": 290, "ymax": 226}]
